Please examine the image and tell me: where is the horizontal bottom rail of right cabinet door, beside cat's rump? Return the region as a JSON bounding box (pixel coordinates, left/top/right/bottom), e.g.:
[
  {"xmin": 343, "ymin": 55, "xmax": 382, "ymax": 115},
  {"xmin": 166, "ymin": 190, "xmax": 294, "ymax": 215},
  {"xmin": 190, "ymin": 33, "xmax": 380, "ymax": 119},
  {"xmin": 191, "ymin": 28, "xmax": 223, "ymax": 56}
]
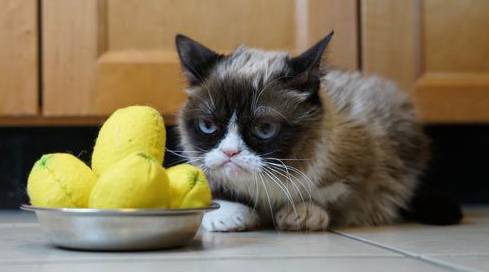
[{"xmin": 413, "ymin": 73, "xmax": 489, "ymax": 123}]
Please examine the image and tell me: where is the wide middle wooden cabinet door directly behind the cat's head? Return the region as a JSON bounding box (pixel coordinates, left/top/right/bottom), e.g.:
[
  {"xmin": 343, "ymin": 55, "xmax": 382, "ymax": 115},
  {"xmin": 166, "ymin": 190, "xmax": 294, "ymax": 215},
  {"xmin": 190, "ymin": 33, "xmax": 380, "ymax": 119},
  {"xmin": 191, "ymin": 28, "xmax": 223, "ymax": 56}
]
[{"xmin": 42, "ymin": 0, "xmax": 358, "ymax": 122}]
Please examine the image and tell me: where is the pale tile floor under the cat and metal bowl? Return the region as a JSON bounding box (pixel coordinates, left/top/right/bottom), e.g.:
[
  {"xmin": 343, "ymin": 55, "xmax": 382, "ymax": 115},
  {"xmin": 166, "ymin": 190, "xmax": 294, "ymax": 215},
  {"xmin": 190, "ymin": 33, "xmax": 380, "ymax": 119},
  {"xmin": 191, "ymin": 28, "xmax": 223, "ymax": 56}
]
[{"xmin": 0, "ymin": 207, "xmax": 489, "ymax": 272}]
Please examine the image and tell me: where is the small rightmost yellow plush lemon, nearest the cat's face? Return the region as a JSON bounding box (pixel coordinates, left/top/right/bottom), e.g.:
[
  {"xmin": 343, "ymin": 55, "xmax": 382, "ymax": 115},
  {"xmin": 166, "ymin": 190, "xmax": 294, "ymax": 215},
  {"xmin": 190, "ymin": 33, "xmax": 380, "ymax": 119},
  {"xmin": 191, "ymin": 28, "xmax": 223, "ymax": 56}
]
[{"xmin": 167, "ymin": 164, "xmax": 212, "ymax": 209}]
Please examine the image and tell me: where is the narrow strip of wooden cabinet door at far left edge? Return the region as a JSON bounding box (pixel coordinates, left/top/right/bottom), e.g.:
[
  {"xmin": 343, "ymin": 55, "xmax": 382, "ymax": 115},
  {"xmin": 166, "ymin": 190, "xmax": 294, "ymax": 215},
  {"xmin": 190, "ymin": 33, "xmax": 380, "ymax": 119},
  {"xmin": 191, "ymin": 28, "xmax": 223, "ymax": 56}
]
[{"xmin": 0, "ymin": 0, "xmax": 39, "ymax": 116}]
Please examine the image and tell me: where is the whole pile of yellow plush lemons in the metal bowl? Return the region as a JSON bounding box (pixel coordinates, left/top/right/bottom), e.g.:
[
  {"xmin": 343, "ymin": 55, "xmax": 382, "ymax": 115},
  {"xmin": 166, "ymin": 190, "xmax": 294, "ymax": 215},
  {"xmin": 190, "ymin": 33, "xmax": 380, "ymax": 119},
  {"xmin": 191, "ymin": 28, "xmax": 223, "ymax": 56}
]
[{"xmin": 27, "ymin": 106, "xmax": 211, "ymax": 209}]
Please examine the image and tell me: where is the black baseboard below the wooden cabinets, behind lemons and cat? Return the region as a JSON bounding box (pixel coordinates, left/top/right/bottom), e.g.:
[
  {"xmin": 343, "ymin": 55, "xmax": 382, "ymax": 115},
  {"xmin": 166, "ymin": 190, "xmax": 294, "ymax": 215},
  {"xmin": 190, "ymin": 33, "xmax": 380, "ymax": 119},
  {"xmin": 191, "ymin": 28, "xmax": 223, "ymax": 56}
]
[{"xmin": 0, "ymin": 125, "xmax": 489, "ymax": 208}]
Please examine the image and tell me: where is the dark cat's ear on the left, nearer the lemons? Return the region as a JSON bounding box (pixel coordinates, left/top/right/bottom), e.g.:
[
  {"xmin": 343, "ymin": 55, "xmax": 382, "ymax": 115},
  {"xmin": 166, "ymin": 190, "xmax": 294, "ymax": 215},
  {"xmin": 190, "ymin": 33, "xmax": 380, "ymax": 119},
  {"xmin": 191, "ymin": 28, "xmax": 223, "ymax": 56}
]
[{"xmin": 175, "ymin": 34, "xmax": 222, "ymax": 85}]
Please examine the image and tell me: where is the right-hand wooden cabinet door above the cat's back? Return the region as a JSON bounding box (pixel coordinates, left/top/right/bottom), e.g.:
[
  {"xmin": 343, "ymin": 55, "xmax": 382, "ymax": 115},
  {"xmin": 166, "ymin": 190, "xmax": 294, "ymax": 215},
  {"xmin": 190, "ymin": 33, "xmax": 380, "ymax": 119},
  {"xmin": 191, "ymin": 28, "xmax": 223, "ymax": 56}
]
[{"xmin": 361, "ymin": 0, "xmax": 489, "ymax": 123}]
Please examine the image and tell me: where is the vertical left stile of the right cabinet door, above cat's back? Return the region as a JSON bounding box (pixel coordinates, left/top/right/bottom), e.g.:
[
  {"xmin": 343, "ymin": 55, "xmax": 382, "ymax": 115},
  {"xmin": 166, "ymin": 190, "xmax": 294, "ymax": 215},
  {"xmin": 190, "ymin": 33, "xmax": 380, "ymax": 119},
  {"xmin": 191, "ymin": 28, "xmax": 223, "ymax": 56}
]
[{"xmin": 361, "ymin": 0, "xmax": 420, "ymax": 90}]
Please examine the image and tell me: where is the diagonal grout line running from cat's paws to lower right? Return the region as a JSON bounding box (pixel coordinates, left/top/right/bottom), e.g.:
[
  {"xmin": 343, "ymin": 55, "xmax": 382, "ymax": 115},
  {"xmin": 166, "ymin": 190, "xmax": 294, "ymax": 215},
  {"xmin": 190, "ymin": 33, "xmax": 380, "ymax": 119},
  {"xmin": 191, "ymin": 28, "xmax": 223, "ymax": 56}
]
[{"xmin": 331, "ymin": 230, "xmax": 480, "ymax": 272}]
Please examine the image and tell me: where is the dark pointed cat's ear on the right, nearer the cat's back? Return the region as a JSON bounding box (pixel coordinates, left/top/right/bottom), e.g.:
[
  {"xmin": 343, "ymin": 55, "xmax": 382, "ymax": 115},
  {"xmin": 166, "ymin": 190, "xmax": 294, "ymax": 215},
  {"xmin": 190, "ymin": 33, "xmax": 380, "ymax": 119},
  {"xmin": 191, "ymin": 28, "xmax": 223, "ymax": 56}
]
[{"xmin": 289, "ymin": 31, "xmax": 334, "ymax": 76}]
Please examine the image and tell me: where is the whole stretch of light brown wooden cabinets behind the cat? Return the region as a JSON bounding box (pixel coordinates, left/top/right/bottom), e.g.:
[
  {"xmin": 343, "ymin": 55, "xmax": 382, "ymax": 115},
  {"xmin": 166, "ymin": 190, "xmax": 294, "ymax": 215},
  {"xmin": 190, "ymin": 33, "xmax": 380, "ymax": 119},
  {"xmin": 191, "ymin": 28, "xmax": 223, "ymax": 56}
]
[{"xmin": 0, "ymin": 0, "xmax": 489, "ymax": 125}]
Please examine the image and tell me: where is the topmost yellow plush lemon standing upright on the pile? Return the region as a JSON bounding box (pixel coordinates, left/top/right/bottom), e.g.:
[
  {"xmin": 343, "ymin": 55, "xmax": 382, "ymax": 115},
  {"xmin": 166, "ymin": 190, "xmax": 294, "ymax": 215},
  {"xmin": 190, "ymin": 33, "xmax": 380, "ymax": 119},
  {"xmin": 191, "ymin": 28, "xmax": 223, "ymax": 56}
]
[{"xmin": 92, "ymin": 106, "xmax": 166, "ymax": 176}]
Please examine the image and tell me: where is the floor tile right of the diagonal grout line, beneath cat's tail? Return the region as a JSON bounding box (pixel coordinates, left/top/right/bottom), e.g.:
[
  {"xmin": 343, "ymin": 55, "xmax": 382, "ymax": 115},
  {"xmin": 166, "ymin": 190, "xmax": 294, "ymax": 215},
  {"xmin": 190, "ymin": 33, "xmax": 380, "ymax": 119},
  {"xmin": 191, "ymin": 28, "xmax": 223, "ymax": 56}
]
[{"xmin": 338, "ymin": 207, "xmax": 489, "ymax": 271}]
